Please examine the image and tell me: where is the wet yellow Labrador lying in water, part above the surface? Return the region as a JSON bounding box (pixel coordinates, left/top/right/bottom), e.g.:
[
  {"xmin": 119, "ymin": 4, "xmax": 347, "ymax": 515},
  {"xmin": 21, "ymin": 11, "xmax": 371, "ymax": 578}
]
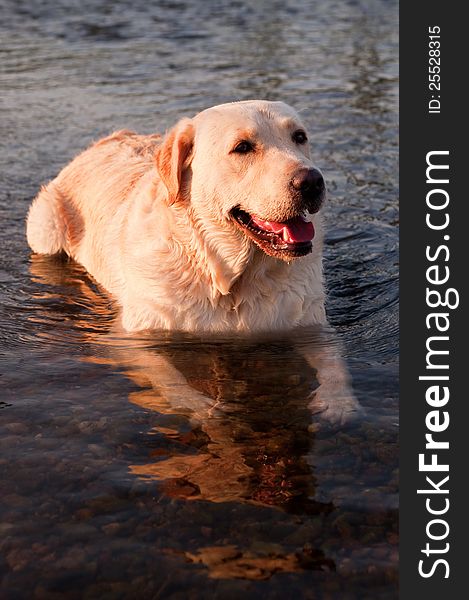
[{"xmin": 27, "ymin": 100, "xmax": 325, "ymax": 332}]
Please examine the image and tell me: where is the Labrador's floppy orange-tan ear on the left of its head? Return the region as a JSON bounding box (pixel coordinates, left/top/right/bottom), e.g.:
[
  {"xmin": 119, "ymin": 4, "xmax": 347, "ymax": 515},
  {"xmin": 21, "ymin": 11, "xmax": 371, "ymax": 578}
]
[{"xmin": 155, "ymin": 119, "xmax": 194, "ymax": 206}]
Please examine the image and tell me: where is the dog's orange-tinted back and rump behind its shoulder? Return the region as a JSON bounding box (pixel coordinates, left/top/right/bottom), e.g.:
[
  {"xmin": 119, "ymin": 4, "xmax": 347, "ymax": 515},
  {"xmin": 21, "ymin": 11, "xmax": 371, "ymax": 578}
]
[{"xmin": 27, "ymin": 130, "xmax": 161, "ymax": 288}]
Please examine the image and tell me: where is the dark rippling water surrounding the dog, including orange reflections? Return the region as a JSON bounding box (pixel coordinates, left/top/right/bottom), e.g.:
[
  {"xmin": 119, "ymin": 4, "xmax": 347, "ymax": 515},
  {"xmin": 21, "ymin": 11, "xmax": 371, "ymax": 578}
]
[{"xmin": 0, "ymin": 0, "xmax": 398, "ymax": 599}]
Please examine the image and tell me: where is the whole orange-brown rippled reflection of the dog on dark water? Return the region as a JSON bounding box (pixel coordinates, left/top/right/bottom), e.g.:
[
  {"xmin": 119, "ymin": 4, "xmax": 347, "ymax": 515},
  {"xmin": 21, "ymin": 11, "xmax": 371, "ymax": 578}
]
[{"xmin": 31, "ymin": 256, "xmax": 359, "ymax": 576}]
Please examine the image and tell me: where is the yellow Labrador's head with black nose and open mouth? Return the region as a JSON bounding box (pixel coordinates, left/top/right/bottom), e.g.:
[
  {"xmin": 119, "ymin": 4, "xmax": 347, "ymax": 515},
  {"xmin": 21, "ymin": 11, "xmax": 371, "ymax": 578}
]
[{"xmin": 157, "ymin": 100, "xmax": 325, "ymax": 261}]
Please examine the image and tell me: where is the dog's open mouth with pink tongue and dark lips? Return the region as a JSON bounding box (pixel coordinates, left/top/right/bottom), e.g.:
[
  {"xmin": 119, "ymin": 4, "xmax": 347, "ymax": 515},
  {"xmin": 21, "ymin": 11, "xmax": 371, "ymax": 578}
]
[{"xmin": 231, "ymin": 207, "xmax": 314, "ymax": 259}]
